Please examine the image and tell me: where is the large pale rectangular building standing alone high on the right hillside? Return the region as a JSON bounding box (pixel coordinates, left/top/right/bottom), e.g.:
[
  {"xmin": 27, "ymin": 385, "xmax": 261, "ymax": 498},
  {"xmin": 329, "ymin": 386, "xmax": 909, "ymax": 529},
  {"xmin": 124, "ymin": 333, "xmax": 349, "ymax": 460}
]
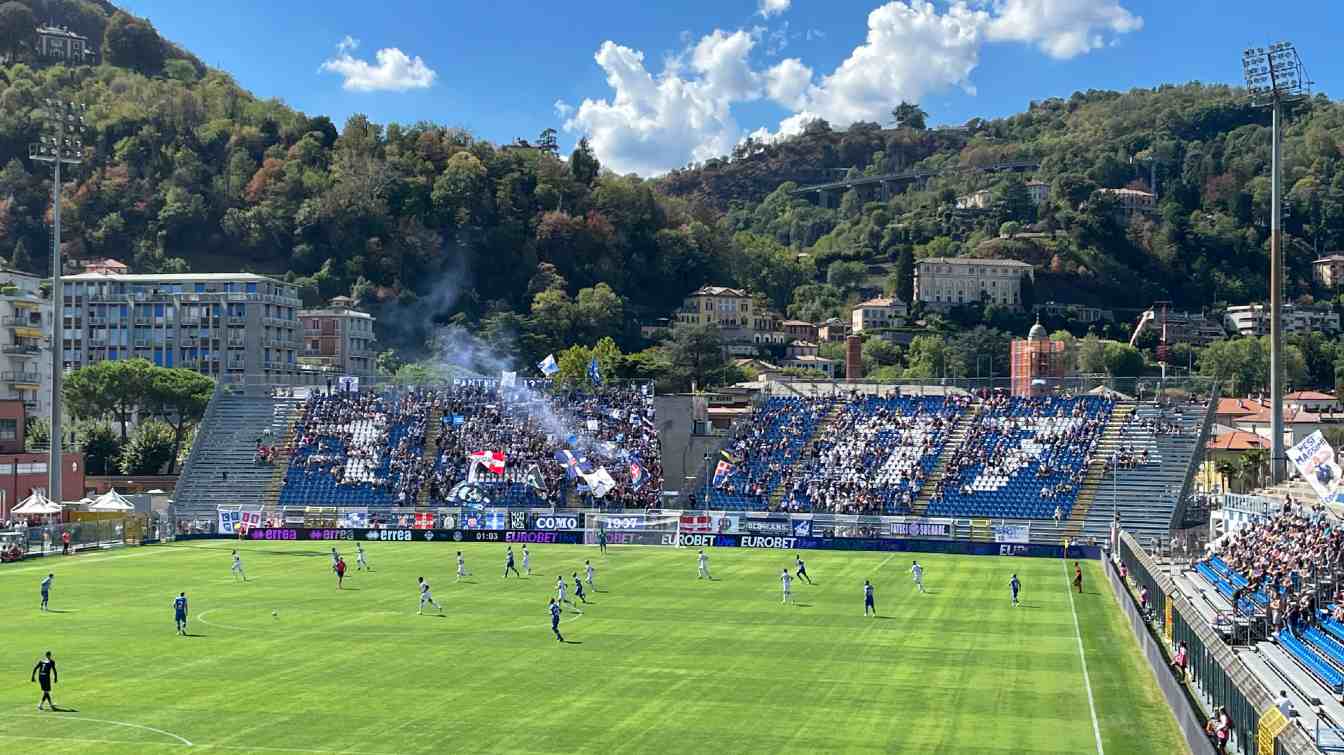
[{"xmin": 915, "ymin": 257, "xmax": 1035, "ymax": 312}]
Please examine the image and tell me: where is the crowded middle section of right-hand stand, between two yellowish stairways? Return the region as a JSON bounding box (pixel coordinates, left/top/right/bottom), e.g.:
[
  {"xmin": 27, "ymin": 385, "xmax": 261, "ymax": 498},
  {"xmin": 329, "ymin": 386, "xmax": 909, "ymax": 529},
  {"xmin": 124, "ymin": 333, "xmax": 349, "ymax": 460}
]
[{"xmin": 784, "ymin": 394, "xmax": 970, "ymax": 515}]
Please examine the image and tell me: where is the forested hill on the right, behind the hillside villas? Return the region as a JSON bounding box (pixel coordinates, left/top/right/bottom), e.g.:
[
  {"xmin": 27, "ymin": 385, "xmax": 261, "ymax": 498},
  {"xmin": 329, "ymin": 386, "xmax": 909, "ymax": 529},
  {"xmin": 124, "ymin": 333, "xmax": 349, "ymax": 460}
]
[{"xmin": 659, "ymin": 83, "xmax": 1344, "ymax": 309}]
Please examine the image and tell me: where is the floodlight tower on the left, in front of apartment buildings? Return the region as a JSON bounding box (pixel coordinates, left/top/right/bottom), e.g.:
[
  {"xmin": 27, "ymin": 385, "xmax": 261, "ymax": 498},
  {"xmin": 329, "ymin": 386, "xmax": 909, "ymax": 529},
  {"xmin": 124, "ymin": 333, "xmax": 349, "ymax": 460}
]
[{"xmin": 28, "ymin": 99, "xmax": 85, "ymax": 504}]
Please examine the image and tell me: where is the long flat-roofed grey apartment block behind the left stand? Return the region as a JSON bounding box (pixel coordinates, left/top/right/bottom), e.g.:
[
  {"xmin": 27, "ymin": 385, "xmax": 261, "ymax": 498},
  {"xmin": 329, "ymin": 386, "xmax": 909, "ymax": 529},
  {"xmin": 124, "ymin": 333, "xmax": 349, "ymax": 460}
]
[{"xmin": 62, "ymin": 273, "xmax": 301, "ymax": 378}]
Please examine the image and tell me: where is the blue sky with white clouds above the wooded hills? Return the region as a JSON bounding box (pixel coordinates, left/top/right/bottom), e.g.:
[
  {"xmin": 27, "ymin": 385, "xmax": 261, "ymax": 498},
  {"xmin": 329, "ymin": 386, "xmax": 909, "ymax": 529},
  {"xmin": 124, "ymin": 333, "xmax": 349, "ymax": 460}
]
[{"xmin": 122, "ymin": 0, "xmax": 1344, "ymax": 173}]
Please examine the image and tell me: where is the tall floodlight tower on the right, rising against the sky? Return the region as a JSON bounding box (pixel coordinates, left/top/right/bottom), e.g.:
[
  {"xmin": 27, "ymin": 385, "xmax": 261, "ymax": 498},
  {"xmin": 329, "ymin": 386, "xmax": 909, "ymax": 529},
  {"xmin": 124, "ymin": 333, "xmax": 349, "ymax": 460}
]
[{"xmin": 1242, "ymin": 42, "xmax": 1312, "ymax": 482}]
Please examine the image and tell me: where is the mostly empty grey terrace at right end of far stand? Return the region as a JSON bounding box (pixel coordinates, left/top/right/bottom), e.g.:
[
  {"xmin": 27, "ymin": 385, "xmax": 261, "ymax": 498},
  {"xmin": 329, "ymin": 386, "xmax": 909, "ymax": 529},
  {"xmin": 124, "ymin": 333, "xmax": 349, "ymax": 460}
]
[{"xmin": 1079, "ymin": 403, "xmax": 1210, "ymax": 545}]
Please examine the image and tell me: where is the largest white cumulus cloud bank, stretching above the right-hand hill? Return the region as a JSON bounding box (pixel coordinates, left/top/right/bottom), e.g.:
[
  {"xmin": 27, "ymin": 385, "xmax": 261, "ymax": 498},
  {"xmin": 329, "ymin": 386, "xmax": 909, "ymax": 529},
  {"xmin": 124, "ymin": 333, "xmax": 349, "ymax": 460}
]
[{"xmin": 556, "ymin": 0, "xmax": 1142, "ymax": 175}]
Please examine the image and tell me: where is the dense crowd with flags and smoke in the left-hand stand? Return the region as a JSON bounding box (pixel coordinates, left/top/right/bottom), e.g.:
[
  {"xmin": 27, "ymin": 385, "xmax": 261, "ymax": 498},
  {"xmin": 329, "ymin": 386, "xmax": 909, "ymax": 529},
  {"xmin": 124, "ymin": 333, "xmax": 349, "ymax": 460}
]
[{"xmin": 280, "ymin": 384, "xmax": 663, "ymax": 508}]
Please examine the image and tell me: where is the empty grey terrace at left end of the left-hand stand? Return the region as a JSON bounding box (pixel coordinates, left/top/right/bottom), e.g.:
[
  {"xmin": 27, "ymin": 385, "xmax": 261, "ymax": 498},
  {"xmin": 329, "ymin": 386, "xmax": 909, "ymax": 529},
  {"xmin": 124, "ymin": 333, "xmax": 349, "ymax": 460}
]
[{"xmin": 173, "ymin": 388, "xmax": 301, "ymax": 510}]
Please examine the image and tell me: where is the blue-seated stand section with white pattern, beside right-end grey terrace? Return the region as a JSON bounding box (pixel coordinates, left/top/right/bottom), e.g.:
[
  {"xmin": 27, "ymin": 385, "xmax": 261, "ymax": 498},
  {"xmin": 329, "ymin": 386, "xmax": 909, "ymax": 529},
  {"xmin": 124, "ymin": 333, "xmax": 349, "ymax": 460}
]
[{"xmin": 927, "ymin": 395, "xmax": 1114, "ymax": 519}]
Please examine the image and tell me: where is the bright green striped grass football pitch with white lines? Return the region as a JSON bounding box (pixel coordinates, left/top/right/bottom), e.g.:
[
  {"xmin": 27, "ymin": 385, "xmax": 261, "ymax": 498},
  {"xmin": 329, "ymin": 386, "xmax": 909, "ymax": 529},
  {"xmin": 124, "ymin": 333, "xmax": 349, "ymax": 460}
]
[{"xmin": 0, "ymin": 540, "xmax": 1185, "ymax": 755}]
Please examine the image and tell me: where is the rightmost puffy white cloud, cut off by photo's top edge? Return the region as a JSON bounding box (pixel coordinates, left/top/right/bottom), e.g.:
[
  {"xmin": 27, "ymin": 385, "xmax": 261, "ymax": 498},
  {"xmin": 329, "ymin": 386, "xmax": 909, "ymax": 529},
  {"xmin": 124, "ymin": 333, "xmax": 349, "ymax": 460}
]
[{"xmin": 985, "ymin": 0, "xmax": 1144, "ymax": 59}]
